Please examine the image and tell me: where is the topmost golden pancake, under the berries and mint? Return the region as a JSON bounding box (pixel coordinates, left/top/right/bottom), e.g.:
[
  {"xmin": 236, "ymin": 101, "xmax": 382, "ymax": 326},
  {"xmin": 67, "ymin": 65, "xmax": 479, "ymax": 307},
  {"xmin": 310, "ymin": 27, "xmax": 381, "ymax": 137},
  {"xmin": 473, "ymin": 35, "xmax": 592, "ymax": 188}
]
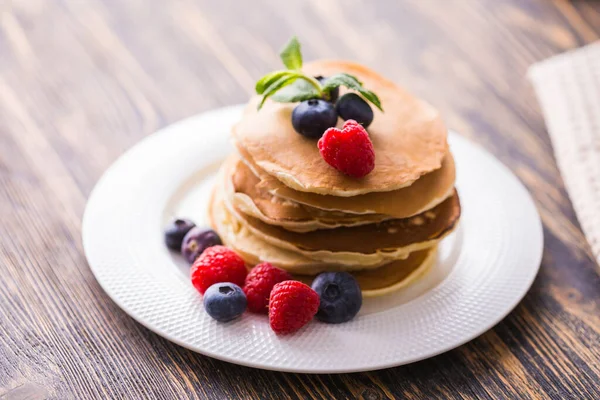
[{"xmin": 232, "ymin": 61, "xmax": 448, "ymax": 197}]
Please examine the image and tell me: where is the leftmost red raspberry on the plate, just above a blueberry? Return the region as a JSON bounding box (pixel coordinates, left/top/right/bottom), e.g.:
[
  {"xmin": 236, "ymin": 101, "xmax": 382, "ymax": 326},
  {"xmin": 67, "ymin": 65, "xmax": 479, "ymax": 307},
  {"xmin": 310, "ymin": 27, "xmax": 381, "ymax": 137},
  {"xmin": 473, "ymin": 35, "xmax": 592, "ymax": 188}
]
[{"xmin": 191, "ymin": 246, "xmax": 248, "ymax": 294}]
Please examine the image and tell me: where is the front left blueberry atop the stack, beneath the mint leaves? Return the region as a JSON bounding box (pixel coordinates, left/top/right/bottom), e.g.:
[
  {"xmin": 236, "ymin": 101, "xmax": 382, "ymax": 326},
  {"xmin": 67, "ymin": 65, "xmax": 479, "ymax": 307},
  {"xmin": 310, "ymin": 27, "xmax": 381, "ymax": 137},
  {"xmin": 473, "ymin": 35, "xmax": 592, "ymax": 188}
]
[{"xmin": 292, "ymin": 99, "xmax": 337, "ymax": 139}]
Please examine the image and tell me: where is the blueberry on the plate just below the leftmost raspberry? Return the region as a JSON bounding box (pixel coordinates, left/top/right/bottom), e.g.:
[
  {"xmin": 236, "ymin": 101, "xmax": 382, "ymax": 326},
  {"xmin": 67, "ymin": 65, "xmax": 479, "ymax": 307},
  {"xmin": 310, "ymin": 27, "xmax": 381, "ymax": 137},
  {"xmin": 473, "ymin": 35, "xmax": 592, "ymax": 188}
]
[{"xmin": 204, "ymin": 282, "xmax": 247, "ymax": 322}]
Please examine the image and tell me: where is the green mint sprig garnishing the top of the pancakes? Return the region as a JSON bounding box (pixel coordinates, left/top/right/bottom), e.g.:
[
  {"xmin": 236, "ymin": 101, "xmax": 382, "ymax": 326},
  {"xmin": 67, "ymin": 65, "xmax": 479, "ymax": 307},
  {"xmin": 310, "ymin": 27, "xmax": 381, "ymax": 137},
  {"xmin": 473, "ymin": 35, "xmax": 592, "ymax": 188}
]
[{"xmin": 255, "ymin": 36, "xmax": 383, "ymax": 111}]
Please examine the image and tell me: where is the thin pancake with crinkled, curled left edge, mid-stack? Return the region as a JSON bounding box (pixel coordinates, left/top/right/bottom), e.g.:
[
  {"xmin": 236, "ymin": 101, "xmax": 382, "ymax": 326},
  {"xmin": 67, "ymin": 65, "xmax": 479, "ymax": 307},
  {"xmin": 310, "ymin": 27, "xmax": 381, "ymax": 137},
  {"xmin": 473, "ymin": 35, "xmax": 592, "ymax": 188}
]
[{"xmin": 226, "ymin": 158, "xmax": 390, "ymax": 232}]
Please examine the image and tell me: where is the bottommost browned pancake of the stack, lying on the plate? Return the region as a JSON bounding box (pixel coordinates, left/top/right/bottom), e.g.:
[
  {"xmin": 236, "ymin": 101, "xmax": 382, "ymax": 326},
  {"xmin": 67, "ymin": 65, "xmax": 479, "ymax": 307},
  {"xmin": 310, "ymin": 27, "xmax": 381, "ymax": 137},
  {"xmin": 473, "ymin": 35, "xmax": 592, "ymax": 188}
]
[{"xmin": 294, "ymin": 248, "xmax": 437, "ymax": 297}]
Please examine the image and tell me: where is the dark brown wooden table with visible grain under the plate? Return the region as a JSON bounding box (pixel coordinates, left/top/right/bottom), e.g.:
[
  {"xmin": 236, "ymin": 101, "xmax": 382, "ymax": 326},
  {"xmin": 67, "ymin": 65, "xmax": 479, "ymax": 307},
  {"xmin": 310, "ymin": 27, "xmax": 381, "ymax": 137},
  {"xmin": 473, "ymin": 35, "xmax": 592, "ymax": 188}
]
[{"xmin": 0, "ymin": 0, "xmax": 600, "ymax": 400}]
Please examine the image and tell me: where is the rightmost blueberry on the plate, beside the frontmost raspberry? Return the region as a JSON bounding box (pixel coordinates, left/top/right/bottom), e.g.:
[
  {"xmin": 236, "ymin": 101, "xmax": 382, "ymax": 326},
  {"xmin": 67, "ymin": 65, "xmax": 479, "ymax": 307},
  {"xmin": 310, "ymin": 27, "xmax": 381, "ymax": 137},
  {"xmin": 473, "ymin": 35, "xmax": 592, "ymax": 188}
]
[{"xmin": 312, "ymin": 272, "xmax": 362, "ymax": 324}]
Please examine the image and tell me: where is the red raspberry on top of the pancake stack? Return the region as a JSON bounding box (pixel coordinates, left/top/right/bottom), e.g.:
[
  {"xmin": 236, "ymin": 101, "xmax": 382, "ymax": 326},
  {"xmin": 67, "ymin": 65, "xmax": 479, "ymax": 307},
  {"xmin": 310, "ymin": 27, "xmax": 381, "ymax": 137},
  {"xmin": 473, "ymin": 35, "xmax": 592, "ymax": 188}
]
[{"xmin": 318, "ymin": 119, "xmax": 375, "ymax": 178}]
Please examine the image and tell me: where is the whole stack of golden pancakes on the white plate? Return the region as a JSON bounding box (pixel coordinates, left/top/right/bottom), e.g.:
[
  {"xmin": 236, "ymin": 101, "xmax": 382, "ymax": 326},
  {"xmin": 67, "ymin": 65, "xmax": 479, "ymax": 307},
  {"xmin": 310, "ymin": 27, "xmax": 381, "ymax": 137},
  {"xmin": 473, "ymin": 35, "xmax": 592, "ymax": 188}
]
[{"xmin": 209, "ymin": 61, "xmax": 460, "ymax": 296}]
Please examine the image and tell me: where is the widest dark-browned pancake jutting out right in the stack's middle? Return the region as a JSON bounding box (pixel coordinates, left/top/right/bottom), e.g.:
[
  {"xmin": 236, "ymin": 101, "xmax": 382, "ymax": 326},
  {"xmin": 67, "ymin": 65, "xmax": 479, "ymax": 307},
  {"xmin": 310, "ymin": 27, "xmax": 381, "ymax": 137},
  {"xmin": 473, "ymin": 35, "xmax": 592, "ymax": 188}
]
[{"xmin": 225, "ymin": 183, "xmax": 460, "ymax": 265}]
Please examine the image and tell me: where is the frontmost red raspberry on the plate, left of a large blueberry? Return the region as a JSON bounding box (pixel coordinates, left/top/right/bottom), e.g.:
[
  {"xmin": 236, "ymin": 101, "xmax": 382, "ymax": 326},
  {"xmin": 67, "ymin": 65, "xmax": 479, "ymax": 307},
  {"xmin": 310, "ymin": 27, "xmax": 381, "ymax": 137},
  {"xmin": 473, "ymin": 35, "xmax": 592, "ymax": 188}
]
[{"xmin": 269, "ymin": 281, "xmax": 319, "ymax": 334}]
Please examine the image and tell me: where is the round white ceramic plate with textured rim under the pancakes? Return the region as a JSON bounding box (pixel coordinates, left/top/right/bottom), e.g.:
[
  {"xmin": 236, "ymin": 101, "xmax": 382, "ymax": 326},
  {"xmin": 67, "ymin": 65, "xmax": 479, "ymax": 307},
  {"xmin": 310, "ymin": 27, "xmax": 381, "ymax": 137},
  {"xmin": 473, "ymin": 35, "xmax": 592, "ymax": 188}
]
[{"xmin": 83, "ymin": 106, "xmax": 543, "ymax": 373}]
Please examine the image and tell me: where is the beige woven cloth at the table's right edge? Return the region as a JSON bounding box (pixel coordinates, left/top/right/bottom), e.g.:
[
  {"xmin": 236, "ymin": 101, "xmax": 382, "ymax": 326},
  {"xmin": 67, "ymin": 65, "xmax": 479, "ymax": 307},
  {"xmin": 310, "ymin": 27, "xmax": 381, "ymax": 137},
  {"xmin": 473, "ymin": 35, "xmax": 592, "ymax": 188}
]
[{"xmin": 528, "ymin": 42, "xmax": 600, "ymax": 263}]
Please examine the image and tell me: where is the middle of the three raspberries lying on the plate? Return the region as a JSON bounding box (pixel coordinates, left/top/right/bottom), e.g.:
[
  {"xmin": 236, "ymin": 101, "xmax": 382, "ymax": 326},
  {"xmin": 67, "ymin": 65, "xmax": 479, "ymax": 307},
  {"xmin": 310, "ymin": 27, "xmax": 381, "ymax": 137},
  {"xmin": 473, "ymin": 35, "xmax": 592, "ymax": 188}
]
[{"xmin": 244, "ymin": 263, "xmax": 292, "ymax": 314}]
